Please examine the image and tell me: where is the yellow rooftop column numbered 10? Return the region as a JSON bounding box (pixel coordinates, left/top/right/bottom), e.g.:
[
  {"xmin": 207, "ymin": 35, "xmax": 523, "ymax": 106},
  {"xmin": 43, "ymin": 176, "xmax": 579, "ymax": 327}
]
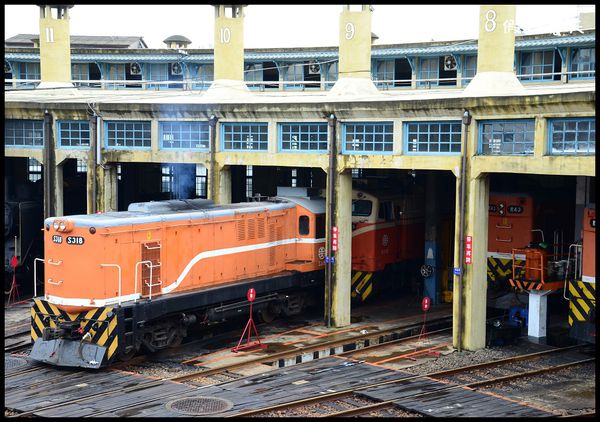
[{"xmin": 214, "ymin": 5, "xmax": 244, "ymax": 81}]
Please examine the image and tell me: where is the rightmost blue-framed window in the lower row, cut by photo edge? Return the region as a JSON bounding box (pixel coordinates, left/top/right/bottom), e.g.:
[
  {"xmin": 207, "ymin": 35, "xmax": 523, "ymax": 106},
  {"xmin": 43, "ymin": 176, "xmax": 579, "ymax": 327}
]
[{"xmin": 549, "ymin": 118, "xmax": 596, "ymax": 155}]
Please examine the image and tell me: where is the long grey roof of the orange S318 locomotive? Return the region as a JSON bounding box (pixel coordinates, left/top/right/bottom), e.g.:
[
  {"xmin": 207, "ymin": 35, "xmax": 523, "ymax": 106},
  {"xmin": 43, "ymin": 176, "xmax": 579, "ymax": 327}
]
[{"xmin": 44, "ymin": 198, "xmax": 304, "ymax": 228}]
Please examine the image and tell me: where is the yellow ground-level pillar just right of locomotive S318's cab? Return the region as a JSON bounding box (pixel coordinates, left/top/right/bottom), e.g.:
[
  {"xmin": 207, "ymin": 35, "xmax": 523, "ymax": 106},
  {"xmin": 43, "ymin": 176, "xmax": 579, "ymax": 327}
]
[{"xmin": 331, "ymin": 172, "xmax": 352, "ymax": 327}]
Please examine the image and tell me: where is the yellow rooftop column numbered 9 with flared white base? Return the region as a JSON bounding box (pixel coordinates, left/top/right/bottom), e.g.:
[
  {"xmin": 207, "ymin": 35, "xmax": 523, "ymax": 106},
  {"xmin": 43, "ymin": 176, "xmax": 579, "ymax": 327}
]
[{"xmin": 329, "ymin": 5, "xmax": 379, "ymax": 95}]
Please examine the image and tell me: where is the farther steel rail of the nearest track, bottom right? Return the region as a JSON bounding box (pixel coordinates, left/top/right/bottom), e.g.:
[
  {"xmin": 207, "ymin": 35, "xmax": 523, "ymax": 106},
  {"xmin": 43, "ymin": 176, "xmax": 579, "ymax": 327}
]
[{"xmin": 234, "ymin": 345, "xmax": 586, "ymax": 417}]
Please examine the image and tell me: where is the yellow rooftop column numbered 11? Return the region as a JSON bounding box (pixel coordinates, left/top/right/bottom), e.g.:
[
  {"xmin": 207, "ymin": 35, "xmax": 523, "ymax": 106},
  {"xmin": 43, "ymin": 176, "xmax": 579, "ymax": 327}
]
[{"xmin": 39, "ymin": 5, "xmax": 73, "ymax": 87}]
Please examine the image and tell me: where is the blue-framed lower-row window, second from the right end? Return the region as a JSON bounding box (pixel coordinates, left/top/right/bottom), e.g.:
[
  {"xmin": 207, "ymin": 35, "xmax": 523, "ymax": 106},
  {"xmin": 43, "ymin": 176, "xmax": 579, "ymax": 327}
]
[{"xmin": 479, "ymin": 119, "xmax": 534, "ymax": 155}]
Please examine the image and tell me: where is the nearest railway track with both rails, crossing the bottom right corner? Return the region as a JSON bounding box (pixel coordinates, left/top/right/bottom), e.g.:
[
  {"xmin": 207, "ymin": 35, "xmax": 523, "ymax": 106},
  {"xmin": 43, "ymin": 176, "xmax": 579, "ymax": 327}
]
[{"xmin": 231, "ymin": 346, "xmax": 595, "ymax": 417}]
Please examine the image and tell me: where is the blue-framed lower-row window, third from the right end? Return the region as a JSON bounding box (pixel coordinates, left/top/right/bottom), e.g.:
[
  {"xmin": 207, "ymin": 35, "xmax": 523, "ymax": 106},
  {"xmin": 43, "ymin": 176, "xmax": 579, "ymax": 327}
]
[{"xmin": 404, "ymin": 121, "xmax": 461, "ymax": 154}]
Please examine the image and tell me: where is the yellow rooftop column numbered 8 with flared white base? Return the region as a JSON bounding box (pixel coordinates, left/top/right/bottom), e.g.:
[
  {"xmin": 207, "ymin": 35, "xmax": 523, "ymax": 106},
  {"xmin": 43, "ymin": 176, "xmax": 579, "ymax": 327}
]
[{"xmin": 464, "ymin": 5, "xmax": 523, "ymax": 96}]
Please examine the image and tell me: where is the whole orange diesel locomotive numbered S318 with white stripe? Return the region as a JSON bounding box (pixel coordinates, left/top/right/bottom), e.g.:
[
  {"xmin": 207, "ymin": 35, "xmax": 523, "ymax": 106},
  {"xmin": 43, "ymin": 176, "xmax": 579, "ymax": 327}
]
[{"xmin": 30, "ymin": 196, "xmax": 325, "ymax": 368}]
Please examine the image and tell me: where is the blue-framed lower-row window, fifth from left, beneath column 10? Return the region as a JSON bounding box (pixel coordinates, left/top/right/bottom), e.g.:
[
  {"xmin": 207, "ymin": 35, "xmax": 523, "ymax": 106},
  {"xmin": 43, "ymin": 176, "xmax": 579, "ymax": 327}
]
[{"xmin": 221, "ymin": 123, "xmax": 268, "ymax": 151}]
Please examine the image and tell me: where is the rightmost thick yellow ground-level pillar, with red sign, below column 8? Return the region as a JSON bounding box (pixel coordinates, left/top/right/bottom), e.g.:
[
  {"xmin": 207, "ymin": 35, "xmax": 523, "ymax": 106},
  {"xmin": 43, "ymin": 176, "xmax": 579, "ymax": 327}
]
[{"xmin": 453, "ymin": 170, "xmax": 489, "ymax": 350}]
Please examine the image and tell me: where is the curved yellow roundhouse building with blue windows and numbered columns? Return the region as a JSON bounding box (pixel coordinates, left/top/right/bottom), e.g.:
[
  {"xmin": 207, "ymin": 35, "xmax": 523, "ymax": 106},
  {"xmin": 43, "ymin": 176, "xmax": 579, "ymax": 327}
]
[{"xmin": 4, "ymin": 5, "xmax": 595, "ymax": 350}]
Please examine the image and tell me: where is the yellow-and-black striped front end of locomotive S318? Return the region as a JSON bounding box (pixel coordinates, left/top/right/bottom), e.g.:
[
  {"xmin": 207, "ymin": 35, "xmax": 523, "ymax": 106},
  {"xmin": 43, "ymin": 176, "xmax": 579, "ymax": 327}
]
[{"xmin": 31, "ymin": 299, "xmax": 119, "ymax": 361}]
